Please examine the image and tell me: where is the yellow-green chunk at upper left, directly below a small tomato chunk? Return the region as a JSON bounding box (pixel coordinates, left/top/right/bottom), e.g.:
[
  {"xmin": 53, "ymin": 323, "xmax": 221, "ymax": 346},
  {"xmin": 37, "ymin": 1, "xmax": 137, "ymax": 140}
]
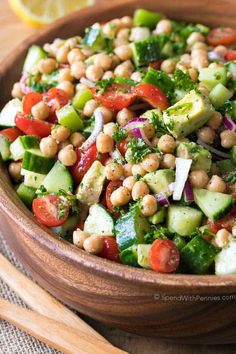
[{"xmin": 56, "ymin": 103, "xmax": 83, "ymax": 132}]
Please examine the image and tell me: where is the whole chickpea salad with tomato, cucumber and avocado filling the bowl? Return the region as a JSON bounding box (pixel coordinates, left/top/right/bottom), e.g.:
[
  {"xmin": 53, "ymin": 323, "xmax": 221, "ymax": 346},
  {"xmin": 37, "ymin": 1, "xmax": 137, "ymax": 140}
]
[{"xmin": 0, "ymin": 9, "xmax": 236, "ymax": 275}]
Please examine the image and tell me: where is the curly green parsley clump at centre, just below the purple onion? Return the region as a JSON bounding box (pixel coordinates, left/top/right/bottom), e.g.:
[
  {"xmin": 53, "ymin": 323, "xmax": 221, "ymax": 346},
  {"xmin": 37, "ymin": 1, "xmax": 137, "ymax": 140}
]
[{"xmin": 128, "ymin": 138, "xmax": 159, "ymax": 163}]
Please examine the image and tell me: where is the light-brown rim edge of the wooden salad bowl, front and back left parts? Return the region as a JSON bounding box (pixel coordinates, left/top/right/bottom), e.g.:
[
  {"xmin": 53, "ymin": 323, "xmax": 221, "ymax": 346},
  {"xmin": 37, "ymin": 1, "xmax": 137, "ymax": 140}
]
[{"xmin": 0, "ymin": 0, "xmax": 236, "ymax": 293}]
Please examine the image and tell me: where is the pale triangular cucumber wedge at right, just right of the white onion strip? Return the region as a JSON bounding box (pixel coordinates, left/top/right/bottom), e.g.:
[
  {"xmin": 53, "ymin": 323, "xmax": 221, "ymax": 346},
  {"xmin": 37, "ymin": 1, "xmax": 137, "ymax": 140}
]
[{"xmin": 193, "ymin": 188, "xmax": 233, "ymax": 221}]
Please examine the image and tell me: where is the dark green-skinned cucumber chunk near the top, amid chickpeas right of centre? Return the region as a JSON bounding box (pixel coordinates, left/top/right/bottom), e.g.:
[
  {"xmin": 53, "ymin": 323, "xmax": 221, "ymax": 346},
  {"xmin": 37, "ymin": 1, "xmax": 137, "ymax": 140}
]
[{"xmin": 131, "ymin": 37, "xmax": 160, "ymax": 66}]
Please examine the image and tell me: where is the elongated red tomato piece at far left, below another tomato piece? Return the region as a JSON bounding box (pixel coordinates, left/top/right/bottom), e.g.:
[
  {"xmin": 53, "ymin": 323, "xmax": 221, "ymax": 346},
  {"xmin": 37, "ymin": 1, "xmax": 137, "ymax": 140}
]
[{"xmin": 15, "ymin": 113, "xmax": 52, "ymax": 138}]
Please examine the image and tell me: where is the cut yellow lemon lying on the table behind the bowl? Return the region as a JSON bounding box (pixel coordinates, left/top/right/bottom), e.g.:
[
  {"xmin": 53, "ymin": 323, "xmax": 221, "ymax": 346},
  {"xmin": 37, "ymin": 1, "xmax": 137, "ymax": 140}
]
[{"xmin": 8, "ymin": 0, "xmax": 94, "ymax": 27}]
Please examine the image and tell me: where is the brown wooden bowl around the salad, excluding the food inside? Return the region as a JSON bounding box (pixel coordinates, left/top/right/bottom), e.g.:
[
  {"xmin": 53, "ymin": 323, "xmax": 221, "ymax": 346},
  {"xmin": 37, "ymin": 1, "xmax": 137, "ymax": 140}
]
[{"xmin": 0, "ymin": 0, "xmax": 236, "ymax": 343}]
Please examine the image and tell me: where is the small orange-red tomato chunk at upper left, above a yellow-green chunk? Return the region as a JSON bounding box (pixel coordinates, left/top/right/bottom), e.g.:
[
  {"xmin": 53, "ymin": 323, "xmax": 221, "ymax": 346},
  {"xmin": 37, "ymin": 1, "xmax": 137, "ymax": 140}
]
[{"xmin": 43, "ymin": 87, "xmax": 69, "ymax": 112}]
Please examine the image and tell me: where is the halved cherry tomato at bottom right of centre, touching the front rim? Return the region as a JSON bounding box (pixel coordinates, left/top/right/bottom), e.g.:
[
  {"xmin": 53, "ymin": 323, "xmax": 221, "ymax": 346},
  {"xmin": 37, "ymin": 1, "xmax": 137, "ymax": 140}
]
[{"xmin": 149, "ymin": 239, "xmax": 180, "ymax": 273}]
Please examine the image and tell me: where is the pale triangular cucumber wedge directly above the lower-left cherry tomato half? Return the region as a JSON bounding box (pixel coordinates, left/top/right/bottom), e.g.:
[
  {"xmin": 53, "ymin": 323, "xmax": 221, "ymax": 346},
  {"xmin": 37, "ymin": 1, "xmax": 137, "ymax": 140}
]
[{"xmin": 39, "ymin": 161, "xmax": 73, "ymax": 193}]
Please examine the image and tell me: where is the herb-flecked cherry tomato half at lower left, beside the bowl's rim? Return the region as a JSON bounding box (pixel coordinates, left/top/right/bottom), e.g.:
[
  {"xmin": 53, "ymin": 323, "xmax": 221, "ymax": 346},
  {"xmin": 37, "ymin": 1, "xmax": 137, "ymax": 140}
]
[{"xmin": 32, "ymin": 195, "xmax": 69, "ymax": 227}]
